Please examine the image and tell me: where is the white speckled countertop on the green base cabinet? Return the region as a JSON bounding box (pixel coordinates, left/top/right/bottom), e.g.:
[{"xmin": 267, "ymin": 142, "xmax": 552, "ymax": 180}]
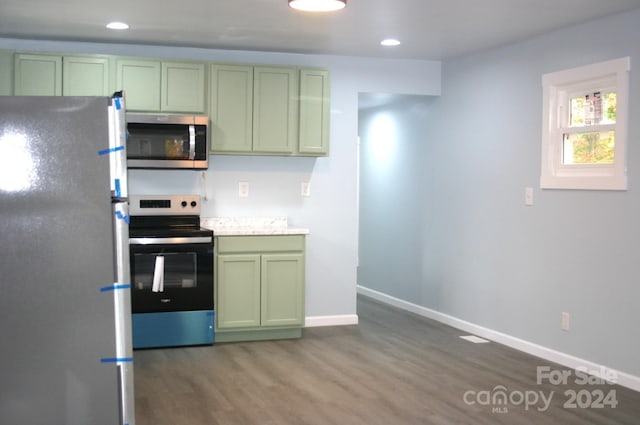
[{"xmin": 200, "ymin": 216, "xmax": 309, "ymax": 236}]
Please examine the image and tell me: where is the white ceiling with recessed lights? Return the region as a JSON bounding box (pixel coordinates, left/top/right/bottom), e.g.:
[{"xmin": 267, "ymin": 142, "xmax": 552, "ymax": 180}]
[{"xmin": 0, "ymin": 0, "xmax": 640, "ymax": 60}]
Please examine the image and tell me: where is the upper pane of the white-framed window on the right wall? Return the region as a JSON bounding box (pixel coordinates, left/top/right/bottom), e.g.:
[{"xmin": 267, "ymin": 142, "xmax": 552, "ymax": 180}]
[{"xmin": 569, "ymin": 92, "xmax": 616, "ymax": 127}]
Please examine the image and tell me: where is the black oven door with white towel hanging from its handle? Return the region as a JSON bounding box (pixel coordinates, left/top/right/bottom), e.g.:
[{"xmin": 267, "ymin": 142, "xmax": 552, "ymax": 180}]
[{"xmin": 129, "ymin": 236, "xmax": 213, "ymax": 313}]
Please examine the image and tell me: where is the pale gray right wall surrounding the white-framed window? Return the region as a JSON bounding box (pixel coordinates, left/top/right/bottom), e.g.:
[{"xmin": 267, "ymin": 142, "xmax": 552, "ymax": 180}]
[{"xmin": 359, "ymin": 11, "xmax": 640, "ymax": 376}]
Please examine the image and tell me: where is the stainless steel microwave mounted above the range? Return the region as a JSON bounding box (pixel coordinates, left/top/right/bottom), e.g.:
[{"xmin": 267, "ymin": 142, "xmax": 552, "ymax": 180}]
[{"xmin": 127, "ymin": 114, "xmax": 209, "ymax": 170}]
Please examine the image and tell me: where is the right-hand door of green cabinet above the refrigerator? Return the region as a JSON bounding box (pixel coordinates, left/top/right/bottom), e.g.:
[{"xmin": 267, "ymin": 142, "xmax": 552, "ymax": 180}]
[{"xmin": 62, "ymin": 56, "xmax": 111, "ymax": 96}]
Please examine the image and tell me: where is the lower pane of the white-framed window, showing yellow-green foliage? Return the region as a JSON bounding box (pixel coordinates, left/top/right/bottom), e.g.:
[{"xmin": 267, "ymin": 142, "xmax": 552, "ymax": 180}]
[{"xmin": 562, "ymin": 131, "xmax": 615, "ymax": 164}]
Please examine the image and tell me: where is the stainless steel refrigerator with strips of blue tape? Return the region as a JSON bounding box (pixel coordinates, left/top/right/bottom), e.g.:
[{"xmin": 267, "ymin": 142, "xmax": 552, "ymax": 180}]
[{"xmin": 0, "ymin": 94, "xmax": 135, "ymax": 425}]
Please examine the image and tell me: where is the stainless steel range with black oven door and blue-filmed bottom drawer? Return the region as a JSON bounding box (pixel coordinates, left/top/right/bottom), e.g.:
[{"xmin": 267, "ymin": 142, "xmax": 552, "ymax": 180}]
[{"xmin": 129, "ymin": 195, "xmax": 215, "ymax": 348}]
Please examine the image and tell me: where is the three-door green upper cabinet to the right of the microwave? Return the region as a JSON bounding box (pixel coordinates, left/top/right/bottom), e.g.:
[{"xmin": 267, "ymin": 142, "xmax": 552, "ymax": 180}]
[{"xmin": 209, "ymin": 64, "xmax": 329, "ymax": 156}]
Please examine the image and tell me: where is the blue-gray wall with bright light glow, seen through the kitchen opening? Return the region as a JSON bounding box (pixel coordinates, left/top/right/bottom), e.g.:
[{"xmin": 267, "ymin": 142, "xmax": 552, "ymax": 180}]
[{"xmin": 358, "ymin": 95, "xmax": 436, "ymax": 302}]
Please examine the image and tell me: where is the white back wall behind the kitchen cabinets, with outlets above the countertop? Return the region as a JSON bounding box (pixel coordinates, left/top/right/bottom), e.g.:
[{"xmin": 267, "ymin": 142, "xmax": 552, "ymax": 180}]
[{"xmin": 0, "ymin": 39, "xmax": 440, "ymax": 317}]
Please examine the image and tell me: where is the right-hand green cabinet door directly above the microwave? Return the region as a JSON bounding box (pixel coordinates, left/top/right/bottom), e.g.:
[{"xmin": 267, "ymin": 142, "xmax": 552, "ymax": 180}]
[{"xmin": 160, "ymin": 62, "xmax": 205, "ymax": 114}]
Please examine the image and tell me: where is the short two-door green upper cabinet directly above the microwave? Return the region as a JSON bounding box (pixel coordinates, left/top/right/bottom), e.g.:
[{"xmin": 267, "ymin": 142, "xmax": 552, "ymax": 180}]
[{"xmin": 116, "ymin": 58, "xmax": 206, "ymax": 114}]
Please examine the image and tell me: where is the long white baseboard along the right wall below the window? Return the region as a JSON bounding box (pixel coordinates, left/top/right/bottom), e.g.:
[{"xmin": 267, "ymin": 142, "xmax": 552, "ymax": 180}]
[{"xmin": 357, "ymin": 285, "xmax": 640, "ymax": 391}]
